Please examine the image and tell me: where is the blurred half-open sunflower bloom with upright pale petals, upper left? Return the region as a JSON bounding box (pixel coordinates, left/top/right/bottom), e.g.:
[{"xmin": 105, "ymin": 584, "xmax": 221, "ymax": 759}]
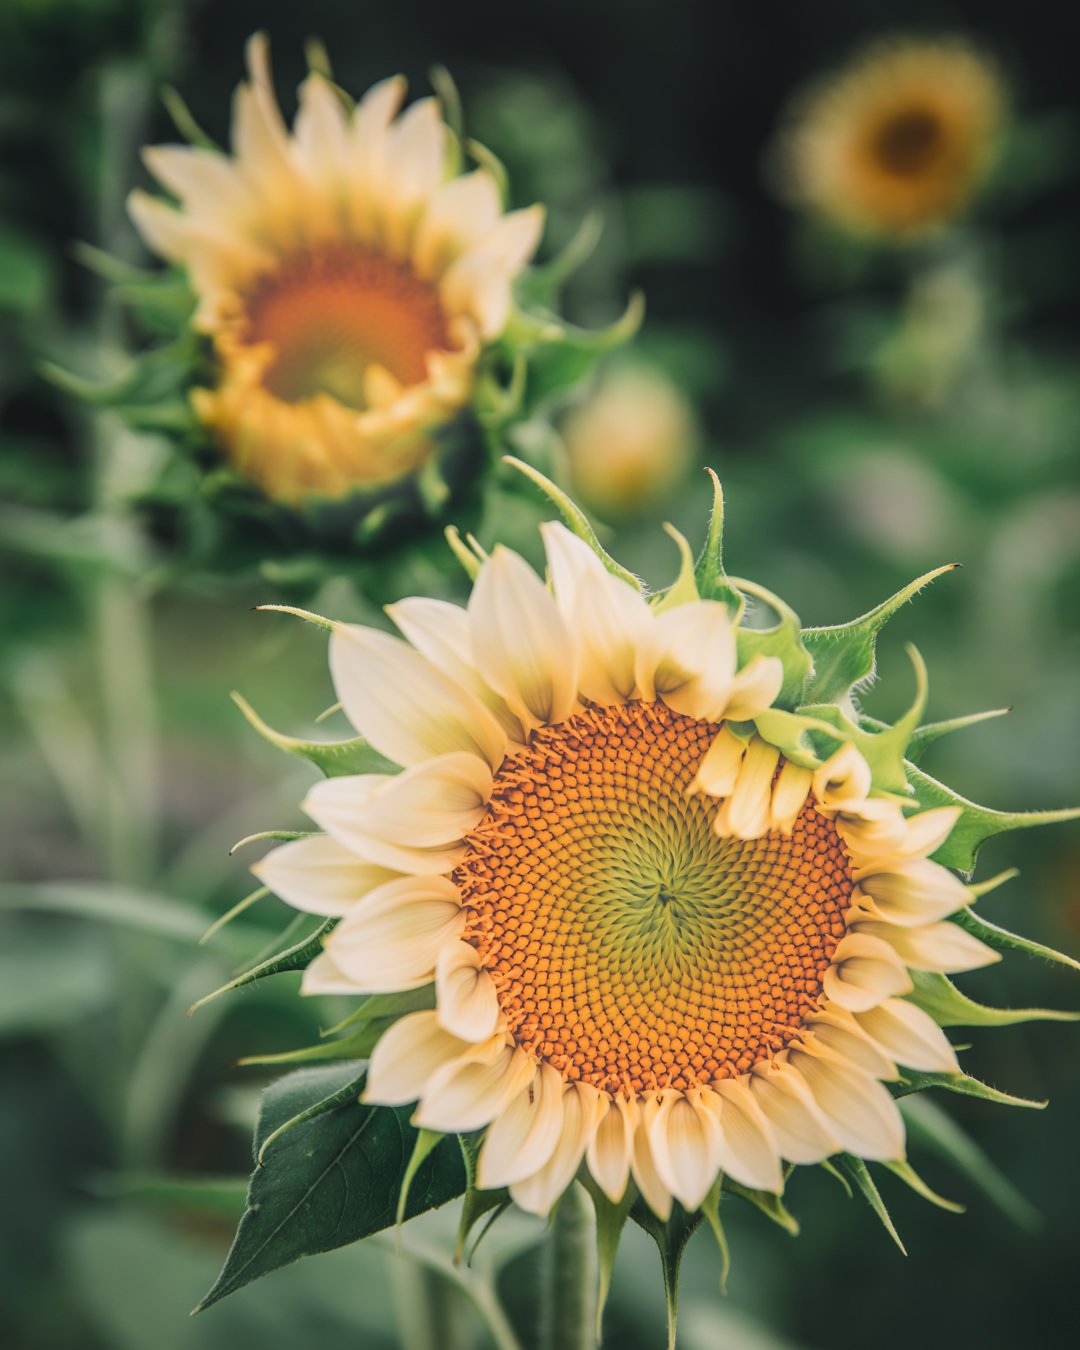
[{"xmin": 130, "ymin": 35, "xmax": 543, "ymax": 506}]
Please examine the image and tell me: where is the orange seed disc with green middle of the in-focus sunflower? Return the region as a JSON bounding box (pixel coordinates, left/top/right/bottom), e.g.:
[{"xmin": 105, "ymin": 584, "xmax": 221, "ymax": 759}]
[{"xmin": 454, "ymin": 703, "xmax": 853, "ymax": 1094}]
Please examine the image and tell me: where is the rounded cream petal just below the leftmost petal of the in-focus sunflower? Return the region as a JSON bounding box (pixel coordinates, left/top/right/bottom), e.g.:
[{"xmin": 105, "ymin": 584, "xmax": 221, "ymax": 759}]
[{"xmin": 325, "ymin": 876, "xmax": 464, "ymax": 994}]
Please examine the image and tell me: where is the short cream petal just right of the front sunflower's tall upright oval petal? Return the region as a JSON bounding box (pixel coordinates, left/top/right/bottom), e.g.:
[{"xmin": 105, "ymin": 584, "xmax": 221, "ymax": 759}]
[{"xmin": 572, "ymin": 572, "xmax": 651, "ymax": 703}]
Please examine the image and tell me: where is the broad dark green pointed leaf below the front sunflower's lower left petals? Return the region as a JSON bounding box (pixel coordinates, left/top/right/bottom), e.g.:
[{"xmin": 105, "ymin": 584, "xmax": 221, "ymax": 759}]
[{"xmin": 198, "ymin": 1064, "xmax": 466, "ymax": 1310}]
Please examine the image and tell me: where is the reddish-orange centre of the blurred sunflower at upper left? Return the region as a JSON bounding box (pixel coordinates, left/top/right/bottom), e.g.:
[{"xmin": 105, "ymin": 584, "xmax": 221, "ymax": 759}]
[{"xmin": 244, "ymin": 244, "xmax": 451, "ymax": 409}]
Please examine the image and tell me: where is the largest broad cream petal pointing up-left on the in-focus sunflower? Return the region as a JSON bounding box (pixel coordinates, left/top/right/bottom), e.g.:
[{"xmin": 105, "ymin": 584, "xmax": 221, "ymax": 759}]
[{"xmin": 329, "ymin": 624, "xmax": 506, "ymax": 770}]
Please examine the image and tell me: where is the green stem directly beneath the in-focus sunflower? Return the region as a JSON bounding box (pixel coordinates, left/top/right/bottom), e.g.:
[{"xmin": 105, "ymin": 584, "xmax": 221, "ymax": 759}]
[{"xmin": 540, "ymin": 1181, "xmax": 598, "ymax": 1350}]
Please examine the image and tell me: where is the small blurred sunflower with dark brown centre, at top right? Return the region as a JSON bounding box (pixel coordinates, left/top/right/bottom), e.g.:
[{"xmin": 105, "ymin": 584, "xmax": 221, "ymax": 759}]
[{"xmin": 780, "ymin": 38, "xmax": 1007, "ymax": 239}]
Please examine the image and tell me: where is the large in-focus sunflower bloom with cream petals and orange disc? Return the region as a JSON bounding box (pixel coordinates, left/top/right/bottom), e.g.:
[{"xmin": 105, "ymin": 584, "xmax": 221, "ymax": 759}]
[{"xmin": 255, "ymin": 510, "xmax": 996, "ymax": 1220}]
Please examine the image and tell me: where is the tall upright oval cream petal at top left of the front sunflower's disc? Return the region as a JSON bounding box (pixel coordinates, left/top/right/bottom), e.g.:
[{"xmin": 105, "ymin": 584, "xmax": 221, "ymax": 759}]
[{"xmin": 468, "ymin": 547, "xmax": 576, "ymax": 728}]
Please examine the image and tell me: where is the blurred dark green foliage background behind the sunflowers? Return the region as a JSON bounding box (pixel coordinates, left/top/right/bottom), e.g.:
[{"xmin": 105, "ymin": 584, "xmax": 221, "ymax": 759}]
[{"xmin": 0, "ymin": 0, "xmax": 1080, "ymax": 1350}]
